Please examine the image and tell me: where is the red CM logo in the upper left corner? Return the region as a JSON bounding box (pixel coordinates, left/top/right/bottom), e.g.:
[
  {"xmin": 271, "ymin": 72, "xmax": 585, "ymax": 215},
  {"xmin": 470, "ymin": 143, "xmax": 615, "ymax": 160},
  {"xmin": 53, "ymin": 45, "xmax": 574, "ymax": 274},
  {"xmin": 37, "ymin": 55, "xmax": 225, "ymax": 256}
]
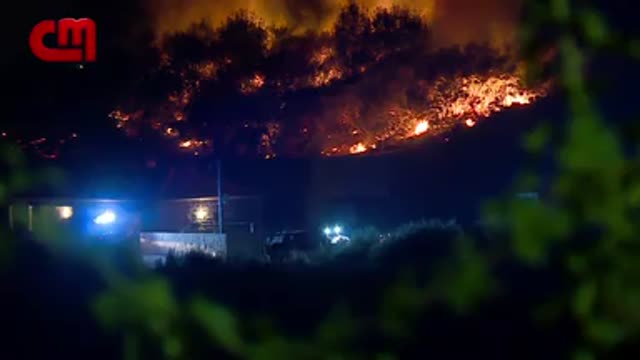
[{"xmin": 29, "ymin": 18, "xmax": 96, "ymax": 63}]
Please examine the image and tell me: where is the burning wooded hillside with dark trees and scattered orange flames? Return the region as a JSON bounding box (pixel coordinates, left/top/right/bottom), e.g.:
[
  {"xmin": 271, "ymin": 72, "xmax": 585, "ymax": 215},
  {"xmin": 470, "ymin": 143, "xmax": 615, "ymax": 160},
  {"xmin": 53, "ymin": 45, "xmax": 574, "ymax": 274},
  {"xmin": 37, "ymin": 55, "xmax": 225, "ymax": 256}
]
[{"xmin": 110, "ymin": 4, "xmax": 548, "ymax": 159}]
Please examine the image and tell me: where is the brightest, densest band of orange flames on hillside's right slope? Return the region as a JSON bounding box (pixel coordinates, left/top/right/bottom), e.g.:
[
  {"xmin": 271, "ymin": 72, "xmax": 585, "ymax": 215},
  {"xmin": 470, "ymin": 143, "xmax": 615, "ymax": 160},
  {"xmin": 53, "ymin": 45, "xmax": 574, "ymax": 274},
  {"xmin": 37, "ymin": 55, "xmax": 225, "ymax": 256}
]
[{"xmin": 322, "ymin": 74, "xmax": 546, "ymax": 156}]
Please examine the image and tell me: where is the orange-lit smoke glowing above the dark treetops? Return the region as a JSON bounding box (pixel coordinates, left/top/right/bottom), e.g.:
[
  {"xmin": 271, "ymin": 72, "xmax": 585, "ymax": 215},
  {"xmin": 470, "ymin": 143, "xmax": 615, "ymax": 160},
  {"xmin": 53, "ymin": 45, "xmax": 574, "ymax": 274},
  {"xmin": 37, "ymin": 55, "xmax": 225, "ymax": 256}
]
[{"xmin": 146, "ymin": 0, "xmax": 521, "ymax": 49}]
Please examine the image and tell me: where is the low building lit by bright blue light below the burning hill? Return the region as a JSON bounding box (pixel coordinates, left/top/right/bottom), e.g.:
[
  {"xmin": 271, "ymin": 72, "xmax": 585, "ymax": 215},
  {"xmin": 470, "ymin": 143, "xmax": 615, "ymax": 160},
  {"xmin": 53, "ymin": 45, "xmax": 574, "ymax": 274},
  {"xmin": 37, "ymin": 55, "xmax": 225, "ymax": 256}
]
[{"xmin": 8, "ymin": 196, "xmax": 263, "ymax": 261}]
